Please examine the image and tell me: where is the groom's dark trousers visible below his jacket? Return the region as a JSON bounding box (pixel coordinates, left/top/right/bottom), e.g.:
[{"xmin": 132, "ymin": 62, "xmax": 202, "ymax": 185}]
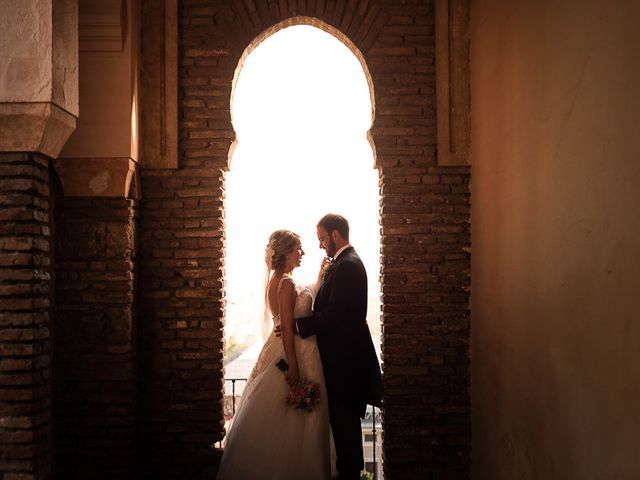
[{"xmin": 329, "ymin": 395, "xmax": 364, "ymax": 480}]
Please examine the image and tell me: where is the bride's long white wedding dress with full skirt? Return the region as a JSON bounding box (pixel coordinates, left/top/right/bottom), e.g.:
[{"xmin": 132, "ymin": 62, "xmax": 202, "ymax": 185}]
[{"xmin": 217, "ymin": 277, "xmax": 331, "ymax": 480}]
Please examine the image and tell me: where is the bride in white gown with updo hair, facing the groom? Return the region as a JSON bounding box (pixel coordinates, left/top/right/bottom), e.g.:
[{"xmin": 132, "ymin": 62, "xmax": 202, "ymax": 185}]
[{"xmin": 217, "ymin": 230, "xmax": 331, "ymax": 480}]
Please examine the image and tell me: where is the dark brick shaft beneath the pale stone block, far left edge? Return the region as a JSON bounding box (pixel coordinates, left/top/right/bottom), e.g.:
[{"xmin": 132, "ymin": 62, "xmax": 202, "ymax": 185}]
[{"xmin": 0, "ymin": 153, "xmax": 51, "ymax": 480}]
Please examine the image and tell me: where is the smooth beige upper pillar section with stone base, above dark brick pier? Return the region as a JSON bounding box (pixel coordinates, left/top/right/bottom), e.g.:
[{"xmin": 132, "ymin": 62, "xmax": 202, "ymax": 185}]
[{"xmin": 55, "ymin": 0, "xmax": 140, "ymax": 198}]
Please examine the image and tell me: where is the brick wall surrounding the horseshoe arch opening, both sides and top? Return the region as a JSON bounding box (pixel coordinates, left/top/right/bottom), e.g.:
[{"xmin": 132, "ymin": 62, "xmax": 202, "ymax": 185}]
[{"xmin": 140, "ymin": 0, "xmax": 471, "ymax": 479}]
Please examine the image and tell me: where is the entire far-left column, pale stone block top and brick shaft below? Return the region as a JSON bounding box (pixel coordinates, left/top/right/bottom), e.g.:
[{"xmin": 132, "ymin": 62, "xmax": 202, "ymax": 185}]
[{"xmin": 0, "ymin": 0, "xmax": 78, "ymax": 479}]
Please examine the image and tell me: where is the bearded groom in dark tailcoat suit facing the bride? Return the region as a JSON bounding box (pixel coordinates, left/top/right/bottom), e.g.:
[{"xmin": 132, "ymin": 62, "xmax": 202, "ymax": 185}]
[{"xmin": 297, "ymin": 214, "xmax": 382, "ymax": 480}]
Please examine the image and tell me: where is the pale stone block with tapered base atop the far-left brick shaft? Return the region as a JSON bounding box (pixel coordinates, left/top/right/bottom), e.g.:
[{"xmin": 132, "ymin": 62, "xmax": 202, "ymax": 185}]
[{"xmin": 0, "ymin": 0, "xmax": 78, "ymax": 157}]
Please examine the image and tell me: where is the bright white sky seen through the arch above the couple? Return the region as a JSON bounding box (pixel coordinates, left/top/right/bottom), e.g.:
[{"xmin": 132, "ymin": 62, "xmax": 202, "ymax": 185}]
[{"xmin": 225, "ymin": 25, "xmax": 380, "ymax": 340}]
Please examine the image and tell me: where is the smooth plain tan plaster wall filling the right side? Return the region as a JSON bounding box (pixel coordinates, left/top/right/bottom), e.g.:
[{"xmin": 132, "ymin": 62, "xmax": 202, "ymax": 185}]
[{"xmin": 471, "ymin": 0, "xmax": 640, "ymax": 480}]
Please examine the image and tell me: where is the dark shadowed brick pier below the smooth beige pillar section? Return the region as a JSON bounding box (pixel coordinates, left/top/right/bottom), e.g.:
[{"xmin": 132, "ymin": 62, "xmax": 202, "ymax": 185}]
[{"xmin": 54, "ymin": 198, "xmax": 137, "ymax": 479}]
